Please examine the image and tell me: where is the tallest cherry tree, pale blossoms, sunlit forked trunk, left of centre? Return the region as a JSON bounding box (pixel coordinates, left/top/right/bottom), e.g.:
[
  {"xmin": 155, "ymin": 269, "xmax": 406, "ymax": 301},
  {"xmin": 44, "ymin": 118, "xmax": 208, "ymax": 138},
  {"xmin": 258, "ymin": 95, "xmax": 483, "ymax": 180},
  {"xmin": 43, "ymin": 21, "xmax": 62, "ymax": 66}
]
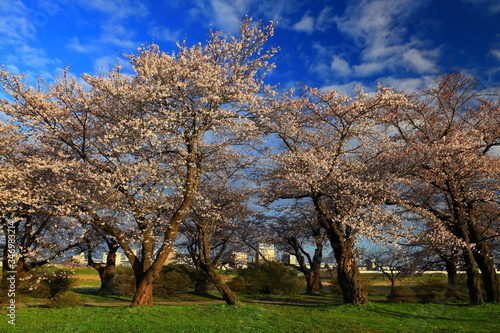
[{"xmin": 0, "ymin": 17, "xmax": 276, "ymax": 305}]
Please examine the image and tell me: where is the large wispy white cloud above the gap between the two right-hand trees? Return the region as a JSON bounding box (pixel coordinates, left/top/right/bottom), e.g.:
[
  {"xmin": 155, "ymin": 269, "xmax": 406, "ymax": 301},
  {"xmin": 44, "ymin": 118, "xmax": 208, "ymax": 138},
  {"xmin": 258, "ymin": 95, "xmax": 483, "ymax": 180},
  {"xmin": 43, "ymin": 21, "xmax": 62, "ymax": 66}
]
[{"xmin": 335, "ymin": 0, "xmax": 440, "ymax": 77}]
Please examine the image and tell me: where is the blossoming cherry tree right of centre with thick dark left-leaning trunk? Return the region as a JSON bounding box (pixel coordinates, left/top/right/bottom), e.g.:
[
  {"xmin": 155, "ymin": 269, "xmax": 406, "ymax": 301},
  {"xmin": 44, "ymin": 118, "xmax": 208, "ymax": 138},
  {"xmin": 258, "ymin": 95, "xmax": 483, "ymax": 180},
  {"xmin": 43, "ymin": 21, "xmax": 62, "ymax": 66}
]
[{"xmin": 260, "ymin": 87, "xmax": 406, "ymax": 304}]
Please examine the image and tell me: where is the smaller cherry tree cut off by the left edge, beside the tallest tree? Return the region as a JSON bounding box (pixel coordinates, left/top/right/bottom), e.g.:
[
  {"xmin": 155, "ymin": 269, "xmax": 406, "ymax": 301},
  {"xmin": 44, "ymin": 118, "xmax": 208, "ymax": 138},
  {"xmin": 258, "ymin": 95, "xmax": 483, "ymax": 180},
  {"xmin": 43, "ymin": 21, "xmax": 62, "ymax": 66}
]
[{"xmin": 0, "ymin": 120, "xmax": 81, "ymax": 284}]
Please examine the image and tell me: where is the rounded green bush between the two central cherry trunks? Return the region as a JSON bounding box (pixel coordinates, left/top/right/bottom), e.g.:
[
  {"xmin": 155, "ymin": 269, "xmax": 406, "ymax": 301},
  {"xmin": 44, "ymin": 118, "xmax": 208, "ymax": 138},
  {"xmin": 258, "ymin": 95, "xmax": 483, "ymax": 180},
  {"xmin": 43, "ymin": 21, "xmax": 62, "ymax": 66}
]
[{"xmin": 228, "ymin": 261, "xmax": 305, "ymax": 294}]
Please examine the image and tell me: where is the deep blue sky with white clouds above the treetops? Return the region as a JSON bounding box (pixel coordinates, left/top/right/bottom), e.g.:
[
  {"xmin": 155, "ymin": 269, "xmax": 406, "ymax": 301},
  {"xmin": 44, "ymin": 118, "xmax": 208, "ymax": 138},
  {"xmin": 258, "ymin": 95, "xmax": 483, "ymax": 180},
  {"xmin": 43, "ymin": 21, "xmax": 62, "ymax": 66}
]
[{"xmin": 0, "ymin": 0, "xmax": 500, "ymax": 92}]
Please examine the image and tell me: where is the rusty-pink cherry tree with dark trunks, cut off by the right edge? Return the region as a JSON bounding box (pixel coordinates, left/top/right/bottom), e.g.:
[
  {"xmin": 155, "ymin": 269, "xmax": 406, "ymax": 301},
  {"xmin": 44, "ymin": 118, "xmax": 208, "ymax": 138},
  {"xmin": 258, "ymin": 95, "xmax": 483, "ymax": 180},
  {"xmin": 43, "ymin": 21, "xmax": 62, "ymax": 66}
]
[{"xmin": 381, "ymin": 72, "xmax": 500, "ymax": 304}]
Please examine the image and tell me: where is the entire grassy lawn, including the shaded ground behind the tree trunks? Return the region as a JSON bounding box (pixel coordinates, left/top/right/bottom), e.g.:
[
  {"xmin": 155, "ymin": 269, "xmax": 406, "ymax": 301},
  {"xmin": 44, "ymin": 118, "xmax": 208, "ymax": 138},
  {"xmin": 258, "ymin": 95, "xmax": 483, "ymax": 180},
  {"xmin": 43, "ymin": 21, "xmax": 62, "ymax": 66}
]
[{"xmin": 0, "ymin": 269, "xmax": 500, "ymax": 333}]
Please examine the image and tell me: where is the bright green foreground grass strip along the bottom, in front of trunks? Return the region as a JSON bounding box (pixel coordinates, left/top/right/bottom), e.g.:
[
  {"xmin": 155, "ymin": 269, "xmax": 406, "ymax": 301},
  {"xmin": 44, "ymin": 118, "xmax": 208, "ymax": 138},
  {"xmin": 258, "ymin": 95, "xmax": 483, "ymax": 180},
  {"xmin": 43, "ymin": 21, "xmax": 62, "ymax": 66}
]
[{"xmin": 0, "ymin": 303, "xmax": 500, "ymax": 333}]
